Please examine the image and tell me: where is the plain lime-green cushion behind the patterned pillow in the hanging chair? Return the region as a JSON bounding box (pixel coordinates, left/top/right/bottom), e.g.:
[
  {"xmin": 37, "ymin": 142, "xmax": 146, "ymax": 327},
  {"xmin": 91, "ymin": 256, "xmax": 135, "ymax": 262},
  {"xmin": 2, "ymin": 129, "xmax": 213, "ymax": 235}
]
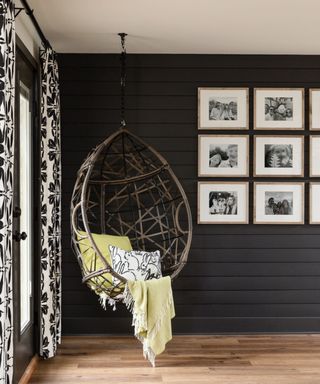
[{"xmin": 78, "ymin": 231, "xmax": 132, "ymax": 294}]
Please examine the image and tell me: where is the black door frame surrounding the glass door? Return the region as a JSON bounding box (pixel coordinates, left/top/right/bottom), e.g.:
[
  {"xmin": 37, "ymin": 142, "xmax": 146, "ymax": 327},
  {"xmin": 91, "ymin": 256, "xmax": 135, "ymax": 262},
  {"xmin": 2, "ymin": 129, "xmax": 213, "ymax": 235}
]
[{"xmin": 13, "ymin": 36, "xmax": 41, "ymax": 383}]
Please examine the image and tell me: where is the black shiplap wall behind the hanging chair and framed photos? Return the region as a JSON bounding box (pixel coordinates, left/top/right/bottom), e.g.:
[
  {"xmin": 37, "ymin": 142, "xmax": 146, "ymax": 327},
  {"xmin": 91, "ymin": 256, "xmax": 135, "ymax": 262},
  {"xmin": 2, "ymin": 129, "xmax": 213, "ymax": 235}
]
[{"xmin": 59, "ymin": 54, "xmax": 320, "ymax": 334}]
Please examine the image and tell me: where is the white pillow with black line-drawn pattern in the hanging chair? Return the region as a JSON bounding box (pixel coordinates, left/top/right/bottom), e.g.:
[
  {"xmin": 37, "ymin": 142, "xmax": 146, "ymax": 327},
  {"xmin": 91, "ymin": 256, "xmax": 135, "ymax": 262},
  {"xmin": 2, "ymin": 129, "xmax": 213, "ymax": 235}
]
[{"xmin": 109, "ymin": 245, "xmax": 162, "ymax": 284}]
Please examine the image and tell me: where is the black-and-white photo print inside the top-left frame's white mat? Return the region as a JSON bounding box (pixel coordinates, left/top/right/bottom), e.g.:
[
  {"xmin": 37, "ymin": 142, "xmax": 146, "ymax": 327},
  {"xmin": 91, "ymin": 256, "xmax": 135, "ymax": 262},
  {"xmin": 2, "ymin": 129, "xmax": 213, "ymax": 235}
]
[{"xmin": 209, "ymin": 97, "xmax": 238, "ymax": 121}]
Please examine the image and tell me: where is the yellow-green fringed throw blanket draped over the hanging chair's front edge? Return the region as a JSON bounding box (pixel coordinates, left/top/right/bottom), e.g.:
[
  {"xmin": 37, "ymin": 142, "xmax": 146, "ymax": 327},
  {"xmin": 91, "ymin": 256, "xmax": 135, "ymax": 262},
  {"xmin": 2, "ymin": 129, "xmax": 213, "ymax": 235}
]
[{"xmin": 124, "ymin": 276, "xmax": 175, "ymax": 366}]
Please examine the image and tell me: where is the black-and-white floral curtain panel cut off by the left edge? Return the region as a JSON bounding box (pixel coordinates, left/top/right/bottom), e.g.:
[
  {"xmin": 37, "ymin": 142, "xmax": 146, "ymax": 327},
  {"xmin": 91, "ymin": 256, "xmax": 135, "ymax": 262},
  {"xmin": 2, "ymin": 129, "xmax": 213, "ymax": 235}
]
[{"xmin": 0, "ymin": 0, "xmax": 15, "ymax": 383}]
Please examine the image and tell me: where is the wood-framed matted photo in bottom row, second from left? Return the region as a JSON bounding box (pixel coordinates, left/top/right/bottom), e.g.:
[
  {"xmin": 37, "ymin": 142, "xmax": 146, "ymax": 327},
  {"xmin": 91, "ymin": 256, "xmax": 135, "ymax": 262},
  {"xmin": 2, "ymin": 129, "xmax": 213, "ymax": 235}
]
[{"xmin": 253, "ymin": 182, "xmax": 304, "ymax": 224}]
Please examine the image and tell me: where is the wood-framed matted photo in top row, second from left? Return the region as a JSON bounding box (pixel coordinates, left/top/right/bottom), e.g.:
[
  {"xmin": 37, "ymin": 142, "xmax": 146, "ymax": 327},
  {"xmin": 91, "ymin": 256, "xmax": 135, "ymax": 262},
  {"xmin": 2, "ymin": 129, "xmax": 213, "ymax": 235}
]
[{"xmin": 254, "ymin": 88, "xmax": 304, "ymax": 129}]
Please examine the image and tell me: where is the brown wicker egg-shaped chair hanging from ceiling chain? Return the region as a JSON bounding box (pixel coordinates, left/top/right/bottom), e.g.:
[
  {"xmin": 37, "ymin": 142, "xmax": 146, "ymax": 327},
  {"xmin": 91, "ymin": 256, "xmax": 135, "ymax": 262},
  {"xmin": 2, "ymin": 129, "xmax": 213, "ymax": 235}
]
[{"xmin": 71, "ymin": 127, "xmax": 192, "ymax": 300}]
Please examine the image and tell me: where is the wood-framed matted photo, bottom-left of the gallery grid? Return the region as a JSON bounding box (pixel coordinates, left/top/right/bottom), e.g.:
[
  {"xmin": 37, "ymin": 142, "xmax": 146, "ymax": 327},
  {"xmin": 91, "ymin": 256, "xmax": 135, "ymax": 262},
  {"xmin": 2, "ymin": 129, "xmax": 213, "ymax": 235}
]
[{"xmin": 198, "ymin": 181, "xmax": 248, "ymax": 224}]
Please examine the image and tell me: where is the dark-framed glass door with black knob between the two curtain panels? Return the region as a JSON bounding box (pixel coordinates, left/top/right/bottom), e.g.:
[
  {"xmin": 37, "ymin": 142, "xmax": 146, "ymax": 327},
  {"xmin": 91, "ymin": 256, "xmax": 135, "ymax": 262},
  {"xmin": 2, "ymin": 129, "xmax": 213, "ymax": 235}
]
[{"xmin": 13, "ymin": 45, "xmax": 36, "ymax": 383}]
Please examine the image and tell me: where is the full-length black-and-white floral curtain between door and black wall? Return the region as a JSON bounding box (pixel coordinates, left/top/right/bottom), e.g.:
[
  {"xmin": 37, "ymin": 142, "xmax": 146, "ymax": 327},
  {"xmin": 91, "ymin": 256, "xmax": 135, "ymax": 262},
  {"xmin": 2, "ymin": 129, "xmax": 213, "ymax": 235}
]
[{"xmin": 40, "ymin": 47, "xmax": 61, "ymax": 358}]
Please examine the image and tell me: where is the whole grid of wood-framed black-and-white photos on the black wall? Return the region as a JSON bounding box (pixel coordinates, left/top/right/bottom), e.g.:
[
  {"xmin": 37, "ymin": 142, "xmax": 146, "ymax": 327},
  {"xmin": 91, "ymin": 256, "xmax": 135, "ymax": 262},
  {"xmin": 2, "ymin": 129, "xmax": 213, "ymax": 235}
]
[{"xmin": 198, "ymin": 87, "xmax": 320, "ymax": 225}]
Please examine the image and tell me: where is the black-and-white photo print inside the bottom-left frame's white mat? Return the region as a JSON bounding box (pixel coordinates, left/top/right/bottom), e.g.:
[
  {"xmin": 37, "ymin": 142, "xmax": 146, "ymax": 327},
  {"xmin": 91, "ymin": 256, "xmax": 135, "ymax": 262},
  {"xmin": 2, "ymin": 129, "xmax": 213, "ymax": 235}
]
[{"xmin": 209, "ymin": 191, "xmax": 238, "ymax": 215}]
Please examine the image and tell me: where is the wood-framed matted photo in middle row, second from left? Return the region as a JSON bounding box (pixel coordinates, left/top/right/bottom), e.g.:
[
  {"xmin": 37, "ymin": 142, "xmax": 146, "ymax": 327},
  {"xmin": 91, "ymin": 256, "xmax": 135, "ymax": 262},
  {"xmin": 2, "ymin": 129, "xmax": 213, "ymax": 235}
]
[{"xmin": 254, "ymin": 135, "xmax": 304, "ymax": 177}]
